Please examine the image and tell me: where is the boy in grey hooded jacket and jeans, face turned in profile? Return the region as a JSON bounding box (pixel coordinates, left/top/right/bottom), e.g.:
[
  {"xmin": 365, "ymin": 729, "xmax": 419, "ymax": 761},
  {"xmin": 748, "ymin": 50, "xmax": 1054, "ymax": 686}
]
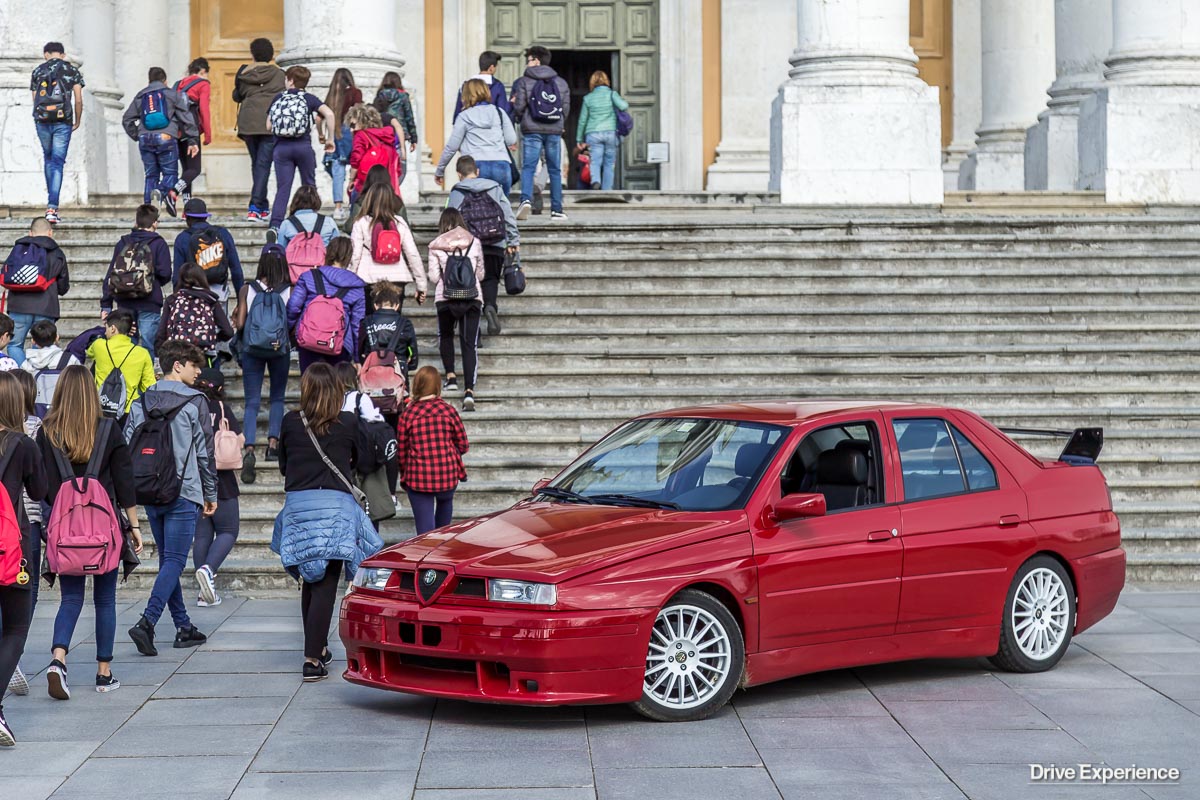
[{"xmin": 125, "ymin": 339, "xmax": 217, "ymax": 656}]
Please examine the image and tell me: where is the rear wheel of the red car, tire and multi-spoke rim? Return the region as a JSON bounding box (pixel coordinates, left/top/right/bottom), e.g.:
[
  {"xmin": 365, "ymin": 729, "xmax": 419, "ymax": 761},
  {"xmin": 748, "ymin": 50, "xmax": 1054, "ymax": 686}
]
[{"xmin": 990, "ymin": 555, "xmax": 1075, "ymax": 672}]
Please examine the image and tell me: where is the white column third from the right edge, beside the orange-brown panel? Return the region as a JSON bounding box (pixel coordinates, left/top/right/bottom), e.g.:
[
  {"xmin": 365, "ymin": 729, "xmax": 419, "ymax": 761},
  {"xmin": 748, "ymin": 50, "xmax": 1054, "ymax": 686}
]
[{"xmin": 959, "ymin": 0, "xmax": 1055, "ymax": 192}]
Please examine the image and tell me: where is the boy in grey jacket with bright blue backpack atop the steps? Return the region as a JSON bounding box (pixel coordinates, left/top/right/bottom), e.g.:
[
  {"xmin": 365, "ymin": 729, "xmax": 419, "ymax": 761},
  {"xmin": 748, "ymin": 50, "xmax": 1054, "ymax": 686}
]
[{"xmin": 121, "ymin": 67, "xmax": 200, "ymax": 217}]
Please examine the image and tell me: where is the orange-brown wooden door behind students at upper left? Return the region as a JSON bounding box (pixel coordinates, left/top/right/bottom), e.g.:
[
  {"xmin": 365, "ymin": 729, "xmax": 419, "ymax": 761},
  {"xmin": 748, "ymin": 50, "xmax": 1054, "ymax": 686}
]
[{"xmin": 192, "ymin": 0, "xmax": 283, "ymax": 150}]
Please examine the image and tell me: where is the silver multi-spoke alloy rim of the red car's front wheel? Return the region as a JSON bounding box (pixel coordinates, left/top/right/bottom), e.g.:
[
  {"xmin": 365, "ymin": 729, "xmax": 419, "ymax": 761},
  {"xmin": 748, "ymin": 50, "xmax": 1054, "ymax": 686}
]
[{"xmin": 644, "ymin": 604, "xmax": 732, "ymax": 709}]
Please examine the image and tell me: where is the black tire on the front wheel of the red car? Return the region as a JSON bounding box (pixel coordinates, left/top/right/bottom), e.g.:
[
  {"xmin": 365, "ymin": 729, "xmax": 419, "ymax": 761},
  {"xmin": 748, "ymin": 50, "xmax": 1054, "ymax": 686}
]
[{"xmin": 632, "ymin": 589, "xmax": 745, "ymax": 722}]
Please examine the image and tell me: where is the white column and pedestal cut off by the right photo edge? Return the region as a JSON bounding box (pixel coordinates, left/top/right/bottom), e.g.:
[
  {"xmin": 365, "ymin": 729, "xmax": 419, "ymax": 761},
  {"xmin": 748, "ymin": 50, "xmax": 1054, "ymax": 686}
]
[{"xmin": 1079, "ymin": 0, "xmax": 1200, "ymax": 204}]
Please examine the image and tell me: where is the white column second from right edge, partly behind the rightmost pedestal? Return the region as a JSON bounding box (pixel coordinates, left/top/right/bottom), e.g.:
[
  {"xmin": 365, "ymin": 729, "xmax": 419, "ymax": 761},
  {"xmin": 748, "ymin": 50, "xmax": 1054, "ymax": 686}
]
[{"xmin": 1025, "ymin": 0, "xmax": 1112, "ymax": 192}]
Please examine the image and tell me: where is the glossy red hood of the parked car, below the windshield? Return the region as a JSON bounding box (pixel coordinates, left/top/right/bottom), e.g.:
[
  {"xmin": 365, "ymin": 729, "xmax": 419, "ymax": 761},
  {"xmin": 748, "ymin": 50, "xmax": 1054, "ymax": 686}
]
[{"xmin": 371, "ymin": 500, "xmax": 748, "ymax": 583}]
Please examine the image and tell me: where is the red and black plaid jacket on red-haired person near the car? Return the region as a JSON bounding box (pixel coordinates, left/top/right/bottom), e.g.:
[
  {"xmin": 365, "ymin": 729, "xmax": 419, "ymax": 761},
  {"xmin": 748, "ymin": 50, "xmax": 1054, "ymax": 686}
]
[{"xmin": 396, "ymin": 397, "xmax": 470, "ymax": 493}]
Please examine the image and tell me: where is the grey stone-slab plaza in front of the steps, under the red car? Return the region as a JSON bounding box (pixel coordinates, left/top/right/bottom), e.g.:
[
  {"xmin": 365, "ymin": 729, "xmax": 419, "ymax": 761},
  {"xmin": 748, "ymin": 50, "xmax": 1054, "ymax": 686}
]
[{"xmin": 0, "ymin": 589, "xmax": 1200, "ymax": 800}]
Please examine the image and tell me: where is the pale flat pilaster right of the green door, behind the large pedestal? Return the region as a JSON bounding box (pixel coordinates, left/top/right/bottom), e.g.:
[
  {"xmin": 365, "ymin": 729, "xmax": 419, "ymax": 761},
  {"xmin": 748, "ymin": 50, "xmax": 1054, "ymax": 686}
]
[{"xmin": 700, "ymin": 0, "xmax": 797, "ymax": 192}]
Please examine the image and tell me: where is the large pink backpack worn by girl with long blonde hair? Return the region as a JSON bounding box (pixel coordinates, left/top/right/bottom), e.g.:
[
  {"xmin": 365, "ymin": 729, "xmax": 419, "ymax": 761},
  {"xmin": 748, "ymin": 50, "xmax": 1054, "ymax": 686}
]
[{"xmin": 46, "ymin": 419, "xmax": 122, "ymax": 576}]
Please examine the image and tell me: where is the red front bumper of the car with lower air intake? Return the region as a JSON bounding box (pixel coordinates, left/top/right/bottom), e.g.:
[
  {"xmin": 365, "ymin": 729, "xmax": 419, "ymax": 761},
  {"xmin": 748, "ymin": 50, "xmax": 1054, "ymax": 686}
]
[{"xmin": 340, "ymin": 593, "xmax": 656, "ymax": 705}]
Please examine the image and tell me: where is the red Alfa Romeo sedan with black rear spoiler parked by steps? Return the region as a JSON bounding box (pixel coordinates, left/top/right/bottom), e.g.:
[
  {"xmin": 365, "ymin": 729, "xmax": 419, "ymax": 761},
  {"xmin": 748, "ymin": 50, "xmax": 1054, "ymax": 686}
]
[{"xmin": 341, "ymin": 402, "xmax": 1126, "ymax": 721}]
